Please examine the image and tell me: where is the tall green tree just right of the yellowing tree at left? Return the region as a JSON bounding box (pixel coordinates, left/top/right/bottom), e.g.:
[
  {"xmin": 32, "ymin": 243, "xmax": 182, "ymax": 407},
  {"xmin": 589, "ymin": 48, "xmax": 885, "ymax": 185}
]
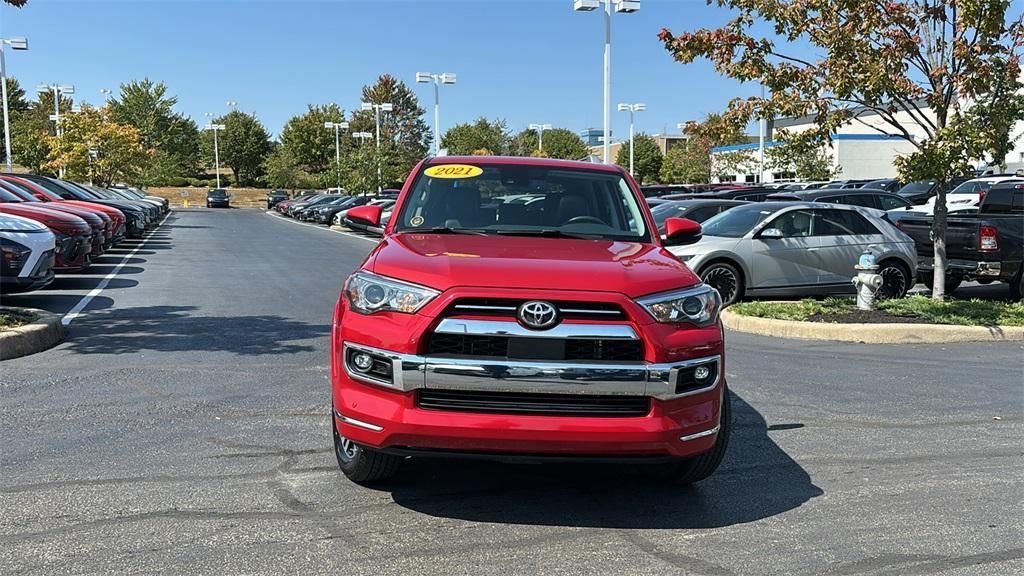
[{"xmin": 108, "ymin": 78, "xmax": 202, "ymax": 186}]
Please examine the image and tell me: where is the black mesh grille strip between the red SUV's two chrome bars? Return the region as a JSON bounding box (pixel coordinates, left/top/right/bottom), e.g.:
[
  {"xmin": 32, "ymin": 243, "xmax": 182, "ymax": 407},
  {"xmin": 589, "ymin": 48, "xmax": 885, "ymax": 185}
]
[{"xmin": 427, "ymin": 334, "xmax": 643, "ymax": 362}]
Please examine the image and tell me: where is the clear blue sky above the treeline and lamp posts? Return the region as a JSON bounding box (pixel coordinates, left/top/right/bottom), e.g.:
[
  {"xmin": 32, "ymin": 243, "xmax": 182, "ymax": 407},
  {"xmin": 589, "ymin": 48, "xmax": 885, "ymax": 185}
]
[{"xmin": 0, "ymin": 0, "xmax": 759, "ymax": 138}]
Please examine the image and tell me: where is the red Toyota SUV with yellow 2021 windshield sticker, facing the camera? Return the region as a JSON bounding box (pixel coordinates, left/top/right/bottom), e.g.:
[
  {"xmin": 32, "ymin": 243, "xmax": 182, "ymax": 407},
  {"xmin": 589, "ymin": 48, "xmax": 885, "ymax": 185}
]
[{"xmin": 331, "ymin": 157, "xmax": 730, "ymax": 483}]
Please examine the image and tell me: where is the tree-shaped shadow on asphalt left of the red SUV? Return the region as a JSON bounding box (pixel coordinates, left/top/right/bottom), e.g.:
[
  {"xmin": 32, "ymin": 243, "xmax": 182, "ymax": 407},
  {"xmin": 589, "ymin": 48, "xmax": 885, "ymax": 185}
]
[{"xmin": 68, "ymin": 306, "xmax": 331, "ymax": 356}]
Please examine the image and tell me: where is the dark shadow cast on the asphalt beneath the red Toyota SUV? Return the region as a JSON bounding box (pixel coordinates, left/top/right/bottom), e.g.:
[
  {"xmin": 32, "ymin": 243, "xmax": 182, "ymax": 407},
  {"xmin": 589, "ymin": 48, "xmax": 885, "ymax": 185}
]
[{"xmin": 380, "ymin": 395, "xmax": 823, "ymax": 529}]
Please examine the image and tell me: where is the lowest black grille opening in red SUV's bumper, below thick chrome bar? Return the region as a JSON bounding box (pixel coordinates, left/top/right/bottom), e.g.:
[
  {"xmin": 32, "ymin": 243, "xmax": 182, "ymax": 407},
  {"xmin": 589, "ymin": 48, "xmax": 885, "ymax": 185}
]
[{"xmin": 417, "ymin": 389, "xmax": 650, "ymax": 418}]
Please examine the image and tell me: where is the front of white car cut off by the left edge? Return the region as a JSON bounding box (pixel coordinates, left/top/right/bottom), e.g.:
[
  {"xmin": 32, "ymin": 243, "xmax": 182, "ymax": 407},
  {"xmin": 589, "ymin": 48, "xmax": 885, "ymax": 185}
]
[{"xmin": 0, "ymin": 214, "xmax": 56, "ymax": 293}]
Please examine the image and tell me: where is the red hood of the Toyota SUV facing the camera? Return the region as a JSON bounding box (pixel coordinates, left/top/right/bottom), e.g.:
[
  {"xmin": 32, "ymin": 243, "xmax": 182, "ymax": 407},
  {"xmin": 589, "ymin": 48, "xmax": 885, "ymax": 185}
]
[{"xmin": 368, "ymin": 234, "xmax": 699, "ymax": 298}]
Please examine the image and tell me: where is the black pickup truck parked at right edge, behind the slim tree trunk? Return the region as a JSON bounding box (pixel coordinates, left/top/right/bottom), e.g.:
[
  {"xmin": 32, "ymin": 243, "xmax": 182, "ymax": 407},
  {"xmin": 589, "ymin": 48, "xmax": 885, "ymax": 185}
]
[{"xmin": 896, "ymin": 181, "xmax": 1024, "ymax": 300}]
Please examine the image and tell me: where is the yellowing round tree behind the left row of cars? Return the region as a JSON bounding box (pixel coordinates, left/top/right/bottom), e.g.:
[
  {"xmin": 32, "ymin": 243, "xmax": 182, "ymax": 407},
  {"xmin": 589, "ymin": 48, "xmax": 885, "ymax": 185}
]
[{"xmin": 43, "ymin": 106, "xmax": 150, "ymax": 186}]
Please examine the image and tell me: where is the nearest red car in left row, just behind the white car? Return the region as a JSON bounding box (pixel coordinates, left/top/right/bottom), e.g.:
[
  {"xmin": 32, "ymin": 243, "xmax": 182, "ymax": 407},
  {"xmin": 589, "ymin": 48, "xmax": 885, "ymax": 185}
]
[{"xmin": 0, "ymin": 190, "xmax": 92, "ymax": 272}]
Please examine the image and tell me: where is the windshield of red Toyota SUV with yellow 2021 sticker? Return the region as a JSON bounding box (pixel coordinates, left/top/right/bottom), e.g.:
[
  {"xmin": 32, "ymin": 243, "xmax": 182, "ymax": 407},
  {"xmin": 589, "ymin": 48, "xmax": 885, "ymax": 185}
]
[{"xmin": 394, "ymin": 164, "xmax": 650, "ymax": 242}]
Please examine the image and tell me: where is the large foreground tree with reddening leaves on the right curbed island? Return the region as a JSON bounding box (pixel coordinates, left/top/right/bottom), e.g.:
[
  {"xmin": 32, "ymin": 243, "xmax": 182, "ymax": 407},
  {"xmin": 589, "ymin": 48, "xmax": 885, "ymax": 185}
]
[{"xmin": 658, "ymin": 0, "xmax": 1024, "ymax": 299}]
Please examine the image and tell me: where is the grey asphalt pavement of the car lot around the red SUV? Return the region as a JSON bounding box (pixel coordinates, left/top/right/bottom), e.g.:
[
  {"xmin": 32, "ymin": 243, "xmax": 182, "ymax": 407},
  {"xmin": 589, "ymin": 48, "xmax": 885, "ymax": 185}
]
[{"xmin": 0, "ymin": 209, "xmax": 1024, "ymax": 575}]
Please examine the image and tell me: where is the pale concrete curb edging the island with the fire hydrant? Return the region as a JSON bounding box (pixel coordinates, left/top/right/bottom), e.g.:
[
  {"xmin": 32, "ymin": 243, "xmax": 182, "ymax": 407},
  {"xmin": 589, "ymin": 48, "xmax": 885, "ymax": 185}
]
[{"xmin": 722, "ymin": 310, "xmax": 1024, "ymax": 344}]
